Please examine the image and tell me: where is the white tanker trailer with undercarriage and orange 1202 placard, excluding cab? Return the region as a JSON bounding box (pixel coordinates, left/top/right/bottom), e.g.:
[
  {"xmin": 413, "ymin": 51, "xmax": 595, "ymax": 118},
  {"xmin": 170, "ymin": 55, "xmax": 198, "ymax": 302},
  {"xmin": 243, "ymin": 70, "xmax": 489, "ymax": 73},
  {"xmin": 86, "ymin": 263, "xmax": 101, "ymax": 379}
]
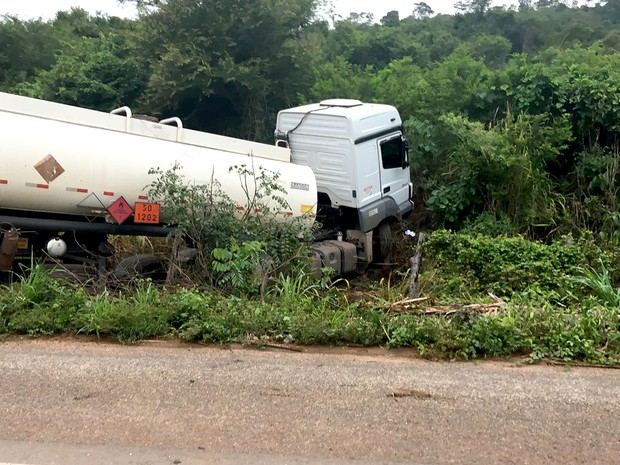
[{"xmin": 0, "ymin": 93, "xmax": 316, "ymax": 278}]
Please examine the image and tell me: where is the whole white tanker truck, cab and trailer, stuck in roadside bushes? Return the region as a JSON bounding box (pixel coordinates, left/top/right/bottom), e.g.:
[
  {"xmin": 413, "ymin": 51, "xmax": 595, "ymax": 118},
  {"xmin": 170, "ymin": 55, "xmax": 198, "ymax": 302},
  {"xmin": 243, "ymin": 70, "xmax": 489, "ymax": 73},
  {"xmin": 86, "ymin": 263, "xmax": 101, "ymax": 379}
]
[{"xmin": 0, "ymin": 93, "xmax": 413, "ymax": 274}]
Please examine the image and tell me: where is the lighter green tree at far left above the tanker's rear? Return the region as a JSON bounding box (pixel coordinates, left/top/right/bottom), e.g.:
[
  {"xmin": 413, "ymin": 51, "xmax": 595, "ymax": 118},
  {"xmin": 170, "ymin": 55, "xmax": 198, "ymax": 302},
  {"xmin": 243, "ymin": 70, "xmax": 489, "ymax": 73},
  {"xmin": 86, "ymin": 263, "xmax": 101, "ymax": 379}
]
[{"xmin": 5, "ymin": 8, "xmax": 148, "ymax": 111}]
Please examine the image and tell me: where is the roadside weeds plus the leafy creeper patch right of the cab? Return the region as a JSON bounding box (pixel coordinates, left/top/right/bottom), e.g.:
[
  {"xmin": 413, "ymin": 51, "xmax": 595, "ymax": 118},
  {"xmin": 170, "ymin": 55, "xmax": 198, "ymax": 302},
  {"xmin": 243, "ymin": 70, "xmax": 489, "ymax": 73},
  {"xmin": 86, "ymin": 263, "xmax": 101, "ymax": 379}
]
[{"xmin": 0, "ymin": 233, "xmax": 620, "ymax": 364}]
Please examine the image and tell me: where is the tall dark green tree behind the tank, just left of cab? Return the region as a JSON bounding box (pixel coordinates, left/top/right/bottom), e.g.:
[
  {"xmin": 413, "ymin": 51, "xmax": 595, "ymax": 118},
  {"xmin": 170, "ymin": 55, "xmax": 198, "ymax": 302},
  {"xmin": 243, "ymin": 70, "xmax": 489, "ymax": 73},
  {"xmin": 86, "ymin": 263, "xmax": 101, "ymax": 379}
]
[{"xmin": 136, "ymin": 0, "xmax": 317, "ymax": 140}]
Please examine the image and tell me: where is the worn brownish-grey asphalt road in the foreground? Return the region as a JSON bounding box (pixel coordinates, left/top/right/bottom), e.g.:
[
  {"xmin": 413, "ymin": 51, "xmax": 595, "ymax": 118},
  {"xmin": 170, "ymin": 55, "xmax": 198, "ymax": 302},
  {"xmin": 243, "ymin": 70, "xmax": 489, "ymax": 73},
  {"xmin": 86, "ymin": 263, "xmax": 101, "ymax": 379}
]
[{"xmin": 0, "ymin": 339, "xmax": 620, "ymax": 465}]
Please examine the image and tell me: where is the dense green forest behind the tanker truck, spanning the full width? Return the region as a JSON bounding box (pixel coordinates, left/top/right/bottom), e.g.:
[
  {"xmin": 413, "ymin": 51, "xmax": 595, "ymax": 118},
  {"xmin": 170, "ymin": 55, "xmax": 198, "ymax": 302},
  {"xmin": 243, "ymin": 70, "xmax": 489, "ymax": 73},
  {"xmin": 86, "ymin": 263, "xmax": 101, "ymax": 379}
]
[{"xmin": 0, "ymin": 0, "xmax": 620, "ymax": 243}]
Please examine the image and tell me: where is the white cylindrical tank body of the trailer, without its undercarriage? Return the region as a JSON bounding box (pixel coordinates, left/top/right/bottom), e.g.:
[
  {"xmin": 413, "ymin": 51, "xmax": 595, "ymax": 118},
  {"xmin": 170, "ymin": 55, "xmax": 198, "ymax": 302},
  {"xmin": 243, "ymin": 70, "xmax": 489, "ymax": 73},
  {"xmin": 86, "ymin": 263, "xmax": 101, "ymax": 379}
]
[{"xmin": 0, "ymin": 93, "xmax": 316, "ymax": 223}]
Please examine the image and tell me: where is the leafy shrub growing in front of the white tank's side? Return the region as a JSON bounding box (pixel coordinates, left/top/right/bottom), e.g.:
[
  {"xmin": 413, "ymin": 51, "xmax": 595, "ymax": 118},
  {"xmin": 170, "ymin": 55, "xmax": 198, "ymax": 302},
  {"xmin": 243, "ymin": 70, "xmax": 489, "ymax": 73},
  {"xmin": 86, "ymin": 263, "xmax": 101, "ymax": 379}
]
[{"xmin": 150, "ymin": 160, "xmax": 310, "ymax": 295}]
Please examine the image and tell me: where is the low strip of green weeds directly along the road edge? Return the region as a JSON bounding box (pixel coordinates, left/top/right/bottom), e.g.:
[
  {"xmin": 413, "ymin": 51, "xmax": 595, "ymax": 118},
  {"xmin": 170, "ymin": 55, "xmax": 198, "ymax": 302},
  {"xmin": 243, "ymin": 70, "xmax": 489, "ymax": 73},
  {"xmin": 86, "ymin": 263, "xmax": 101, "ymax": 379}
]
[{"xmin": 0, "ymin": 262, "xmax": 620, "ymax": 364}]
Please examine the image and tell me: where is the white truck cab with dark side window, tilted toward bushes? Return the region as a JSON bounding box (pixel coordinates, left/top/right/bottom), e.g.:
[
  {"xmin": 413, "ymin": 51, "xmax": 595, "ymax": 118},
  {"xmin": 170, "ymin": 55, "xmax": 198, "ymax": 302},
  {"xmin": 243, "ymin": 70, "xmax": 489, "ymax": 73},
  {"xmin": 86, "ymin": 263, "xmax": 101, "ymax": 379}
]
[{"xmin": 275, "ymin": 99, "xmax": 413, "ymax": 232}]
